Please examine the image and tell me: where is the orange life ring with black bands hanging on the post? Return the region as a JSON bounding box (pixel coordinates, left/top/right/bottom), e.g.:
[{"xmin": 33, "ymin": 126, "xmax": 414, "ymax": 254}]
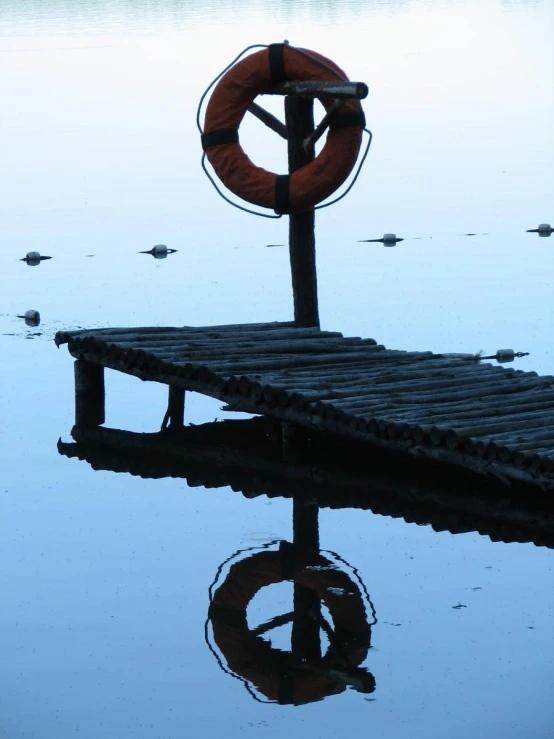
[{"xmin": 202, "ymin": 44, "xmax": 365, "ymax": 213}]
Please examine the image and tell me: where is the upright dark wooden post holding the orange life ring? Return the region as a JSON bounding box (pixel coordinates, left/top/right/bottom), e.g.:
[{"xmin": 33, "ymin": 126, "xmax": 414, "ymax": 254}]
[{"xmin": 285, "ymin": 95, "xmax": 319, "ymax": 328}]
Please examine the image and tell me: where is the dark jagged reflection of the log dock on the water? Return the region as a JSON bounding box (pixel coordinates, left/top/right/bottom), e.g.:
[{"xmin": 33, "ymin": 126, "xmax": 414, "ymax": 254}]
[{"xmin": 58, "ymin": 418, "xmax": 554, "ymax": 547}]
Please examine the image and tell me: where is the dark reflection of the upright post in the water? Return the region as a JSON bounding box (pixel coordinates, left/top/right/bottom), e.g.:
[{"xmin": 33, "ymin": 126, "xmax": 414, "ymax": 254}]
[{"xmin": 292, "ymin": 497, "xmax": 321, "ymax": 660}]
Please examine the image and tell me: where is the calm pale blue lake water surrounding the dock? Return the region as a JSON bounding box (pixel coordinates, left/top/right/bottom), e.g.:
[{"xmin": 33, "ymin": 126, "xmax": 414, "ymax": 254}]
[{"xmin": 0, "ymin": 0, "xmax": 554, "ymax": 739}]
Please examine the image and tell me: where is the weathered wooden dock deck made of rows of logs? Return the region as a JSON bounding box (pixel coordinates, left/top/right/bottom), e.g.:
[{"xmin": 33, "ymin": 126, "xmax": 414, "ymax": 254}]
[{"xmin": 55, "ymin": 323, "xmax": 554, "ymax": 489}]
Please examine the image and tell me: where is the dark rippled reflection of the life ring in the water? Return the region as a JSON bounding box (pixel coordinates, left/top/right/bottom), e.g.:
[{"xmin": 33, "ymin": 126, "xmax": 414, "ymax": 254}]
[{"xmin": 209, "ymin": 542, "xmax": 375, "ymax": 705}]
